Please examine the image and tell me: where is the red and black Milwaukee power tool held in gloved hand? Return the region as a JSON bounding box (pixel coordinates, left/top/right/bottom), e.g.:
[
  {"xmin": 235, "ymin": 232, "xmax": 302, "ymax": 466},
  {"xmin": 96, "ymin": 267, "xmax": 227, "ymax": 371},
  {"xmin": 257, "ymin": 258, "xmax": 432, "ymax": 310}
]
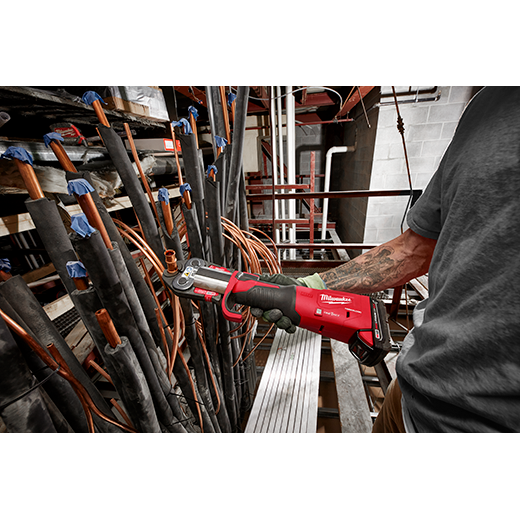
[{"xmin": 163, "ymin": 258, "xmax": 391, "ymax": 366}]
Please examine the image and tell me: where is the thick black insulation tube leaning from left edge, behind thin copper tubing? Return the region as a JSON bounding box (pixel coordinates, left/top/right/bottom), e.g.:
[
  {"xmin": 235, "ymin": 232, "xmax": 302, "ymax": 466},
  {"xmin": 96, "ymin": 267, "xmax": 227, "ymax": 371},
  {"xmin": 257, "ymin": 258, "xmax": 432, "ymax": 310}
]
[{"xmin": 0, "ymin": 275, "xmax": 122, "ymax": 433}]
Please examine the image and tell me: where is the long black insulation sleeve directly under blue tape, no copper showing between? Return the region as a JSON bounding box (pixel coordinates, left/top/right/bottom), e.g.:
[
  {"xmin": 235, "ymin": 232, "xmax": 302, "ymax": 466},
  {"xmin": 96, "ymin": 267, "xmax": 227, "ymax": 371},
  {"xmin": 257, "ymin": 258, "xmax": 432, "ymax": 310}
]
[{"xmin": 71, "ymin": 231, "xmax": 183, "ymax": 432}]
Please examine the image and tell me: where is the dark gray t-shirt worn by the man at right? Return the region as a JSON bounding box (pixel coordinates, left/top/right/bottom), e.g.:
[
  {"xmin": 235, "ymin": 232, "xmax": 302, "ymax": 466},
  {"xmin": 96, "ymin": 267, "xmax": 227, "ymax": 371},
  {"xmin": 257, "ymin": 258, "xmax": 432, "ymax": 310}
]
[{"xmin": 397, "ymin": 87, "xmax": 520, "ymax": 432}]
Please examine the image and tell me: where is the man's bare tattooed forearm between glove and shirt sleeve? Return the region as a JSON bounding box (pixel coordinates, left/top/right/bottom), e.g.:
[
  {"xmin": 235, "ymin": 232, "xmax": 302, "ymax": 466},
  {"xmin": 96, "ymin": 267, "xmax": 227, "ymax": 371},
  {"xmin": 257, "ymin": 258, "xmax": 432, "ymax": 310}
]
[{"xmin": 320, "ymin": 229, "xmax": 437, "ymax": 294}]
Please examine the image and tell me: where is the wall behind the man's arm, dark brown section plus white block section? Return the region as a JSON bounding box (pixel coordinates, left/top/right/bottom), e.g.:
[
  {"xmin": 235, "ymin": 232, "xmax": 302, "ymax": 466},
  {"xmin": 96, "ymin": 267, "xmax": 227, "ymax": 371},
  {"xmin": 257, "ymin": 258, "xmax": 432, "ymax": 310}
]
[{"xmin": 331, "ymin": 86, "xmax": 479, "ymax": 256}]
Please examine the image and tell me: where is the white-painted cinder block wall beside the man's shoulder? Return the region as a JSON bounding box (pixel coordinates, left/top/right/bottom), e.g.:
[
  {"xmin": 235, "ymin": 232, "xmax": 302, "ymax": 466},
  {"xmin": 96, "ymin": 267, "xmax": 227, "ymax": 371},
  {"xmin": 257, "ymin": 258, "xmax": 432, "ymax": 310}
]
[{"xmin": 363, "ymin": 86, "xmax": 478, "ymax": 243}]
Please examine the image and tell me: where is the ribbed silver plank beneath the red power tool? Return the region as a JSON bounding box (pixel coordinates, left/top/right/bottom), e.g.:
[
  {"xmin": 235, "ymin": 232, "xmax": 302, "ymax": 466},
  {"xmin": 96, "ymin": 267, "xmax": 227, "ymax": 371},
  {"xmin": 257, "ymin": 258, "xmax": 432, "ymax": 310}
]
[{"xmin": 245, "ymin": 328, "xmax": 321, "ymax": 433}]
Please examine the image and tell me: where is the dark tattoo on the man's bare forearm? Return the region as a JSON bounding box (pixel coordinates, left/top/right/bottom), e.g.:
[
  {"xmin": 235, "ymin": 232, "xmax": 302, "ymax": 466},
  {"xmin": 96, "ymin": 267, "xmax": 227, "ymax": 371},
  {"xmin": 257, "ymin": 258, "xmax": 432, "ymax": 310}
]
[{"xmin": 320, "ymin": 244, "xmax": 405, "ymax": 293}]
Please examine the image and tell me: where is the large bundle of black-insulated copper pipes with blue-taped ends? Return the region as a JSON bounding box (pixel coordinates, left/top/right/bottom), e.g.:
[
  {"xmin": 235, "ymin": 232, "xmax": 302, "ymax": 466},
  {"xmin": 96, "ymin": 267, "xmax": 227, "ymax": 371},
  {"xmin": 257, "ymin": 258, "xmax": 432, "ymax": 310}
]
[{"xmin": 0, "ymin": 87, "xmax": 280, "ymax": 433}]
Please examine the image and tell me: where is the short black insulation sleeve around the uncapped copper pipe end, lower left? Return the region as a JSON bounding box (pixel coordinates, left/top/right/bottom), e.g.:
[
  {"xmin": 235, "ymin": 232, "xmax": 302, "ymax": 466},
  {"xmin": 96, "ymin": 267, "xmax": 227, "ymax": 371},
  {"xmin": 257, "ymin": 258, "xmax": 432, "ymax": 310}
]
[{"xmin": 104, "ymin": 336, "xmax": 161, "ymax": 433}]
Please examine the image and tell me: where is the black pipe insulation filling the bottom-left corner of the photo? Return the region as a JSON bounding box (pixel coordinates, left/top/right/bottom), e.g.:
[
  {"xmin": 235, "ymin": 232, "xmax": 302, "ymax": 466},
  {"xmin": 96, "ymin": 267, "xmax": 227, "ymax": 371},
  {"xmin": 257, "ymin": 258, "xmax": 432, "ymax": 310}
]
[{"xmin": 0, "ymin": 318, "xmax": 56, "ymax": 433}]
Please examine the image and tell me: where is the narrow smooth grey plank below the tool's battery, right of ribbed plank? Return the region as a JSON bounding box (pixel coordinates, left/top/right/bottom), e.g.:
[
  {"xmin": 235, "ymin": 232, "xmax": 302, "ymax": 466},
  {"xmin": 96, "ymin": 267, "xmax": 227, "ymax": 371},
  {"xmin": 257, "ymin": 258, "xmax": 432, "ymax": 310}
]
[{"xmin": 331, "ymin": 339, "xmax": 372, "ymax": 433}]
